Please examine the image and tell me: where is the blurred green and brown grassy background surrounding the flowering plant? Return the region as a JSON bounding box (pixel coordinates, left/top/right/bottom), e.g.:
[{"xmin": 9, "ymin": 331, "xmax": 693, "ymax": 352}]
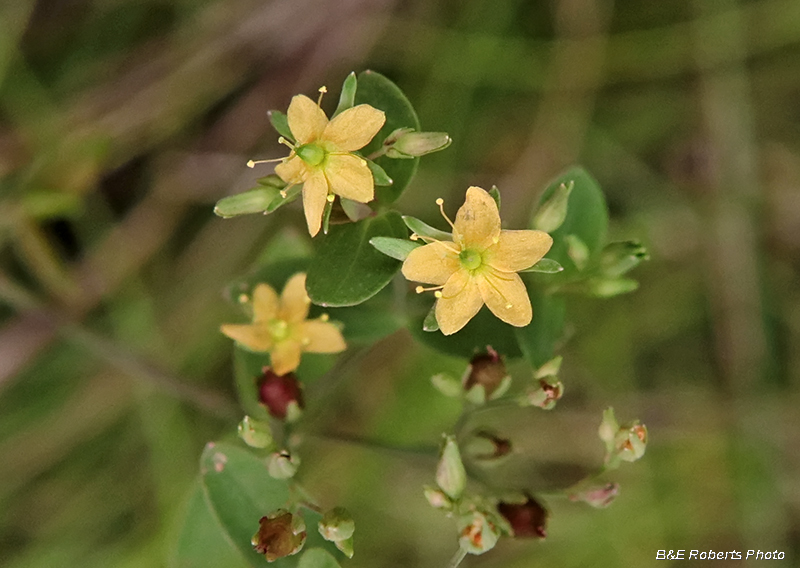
[{"xmin": 0, "ymin": 0, "xmax": 800, "ymax": 568}]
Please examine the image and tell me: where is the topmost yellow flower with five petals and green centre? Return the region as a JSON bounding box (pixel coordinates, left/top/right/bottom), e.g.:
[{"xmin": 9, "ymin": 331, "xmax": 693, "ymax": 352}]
[{"xmin": 275, "ymin": 91, "xmax": 386, "ymax": 237}]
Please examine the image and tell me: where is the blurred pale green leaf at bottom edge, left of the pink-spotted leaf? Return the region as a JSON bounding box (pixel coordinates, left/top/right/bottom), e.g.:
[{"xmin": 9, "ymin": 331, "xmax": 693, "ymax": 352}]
[{"xmin": 170, "ymin": 483, "xmax": 244, "ymax": 568}]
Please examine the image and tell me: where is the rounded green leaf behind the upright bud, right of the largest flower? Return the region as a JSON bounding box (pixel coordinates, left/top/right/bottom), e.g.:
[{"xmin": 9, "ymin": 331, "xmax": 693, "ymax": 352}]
[{"xmin": 531, "ymin": 166, "xmax": 608, "ymax": 276}]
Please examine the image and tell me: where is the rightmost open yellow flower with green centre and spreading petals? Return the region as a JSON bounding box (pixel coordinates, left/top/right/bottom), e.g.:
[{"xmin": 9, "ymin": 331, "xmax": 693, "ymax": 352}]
[{"xmin": 403, "ymin": 187, "xmax": 553, "ymax": 335}]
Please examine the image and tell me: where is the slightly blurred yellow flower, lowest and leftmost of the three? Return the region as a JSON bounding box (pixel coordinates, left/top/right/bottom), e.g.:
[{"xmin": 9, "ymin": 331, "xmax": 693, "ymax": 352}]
[{"xmin": 221, "ymin": 273, "xmax": 347, "ymax": 375}]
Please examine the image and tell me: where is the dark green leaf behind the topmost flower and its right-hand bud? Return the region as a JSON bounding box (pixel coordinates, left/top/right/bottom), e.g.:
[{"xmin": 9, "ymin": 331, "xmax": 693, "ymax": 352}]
[{"xmin": 355, "ymin": 71, "xmax": 420, "ymax": 205}]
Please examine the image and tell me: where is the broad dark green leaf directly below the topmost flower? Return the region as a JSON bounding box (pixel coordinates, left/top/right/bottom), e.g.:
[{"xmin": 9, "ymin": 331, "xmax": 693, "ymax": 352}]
[{"xmin": 306, "ymin": 211, "xmax": 408, "ymax": 307}]
